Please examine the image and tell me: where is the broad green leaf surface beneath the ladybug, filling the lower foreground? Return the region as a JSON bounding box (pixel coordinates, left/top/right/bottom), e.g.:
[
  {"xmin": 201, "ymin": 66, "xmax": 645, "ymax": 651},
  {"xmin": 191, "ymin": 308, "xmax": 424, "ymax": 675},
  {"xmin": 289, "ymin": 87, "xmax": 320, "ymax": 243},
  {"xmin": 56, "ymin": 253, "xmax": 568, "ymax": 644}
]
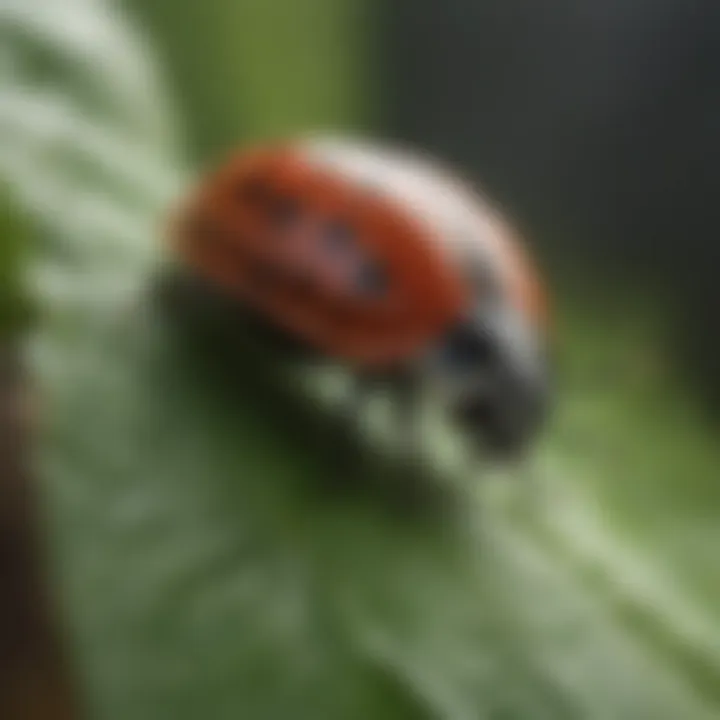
[{"xmin": 36, "ymin": 288, "xmax": 711, "ymax": 718}]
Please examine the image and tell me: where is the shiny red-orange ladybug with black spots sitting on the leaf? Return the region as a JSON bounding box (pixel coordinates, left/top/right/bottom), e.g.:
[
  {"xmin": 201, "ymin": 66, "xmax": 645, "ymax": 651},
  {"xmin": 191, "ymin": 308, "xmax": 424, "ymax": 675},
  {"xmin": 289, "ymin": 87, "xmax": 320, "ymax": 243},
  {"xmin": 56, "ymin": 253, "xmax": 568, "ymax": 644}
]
[{"xmin": 172, "ymin": 137, "xmax": 549, "ymax": 457}]
